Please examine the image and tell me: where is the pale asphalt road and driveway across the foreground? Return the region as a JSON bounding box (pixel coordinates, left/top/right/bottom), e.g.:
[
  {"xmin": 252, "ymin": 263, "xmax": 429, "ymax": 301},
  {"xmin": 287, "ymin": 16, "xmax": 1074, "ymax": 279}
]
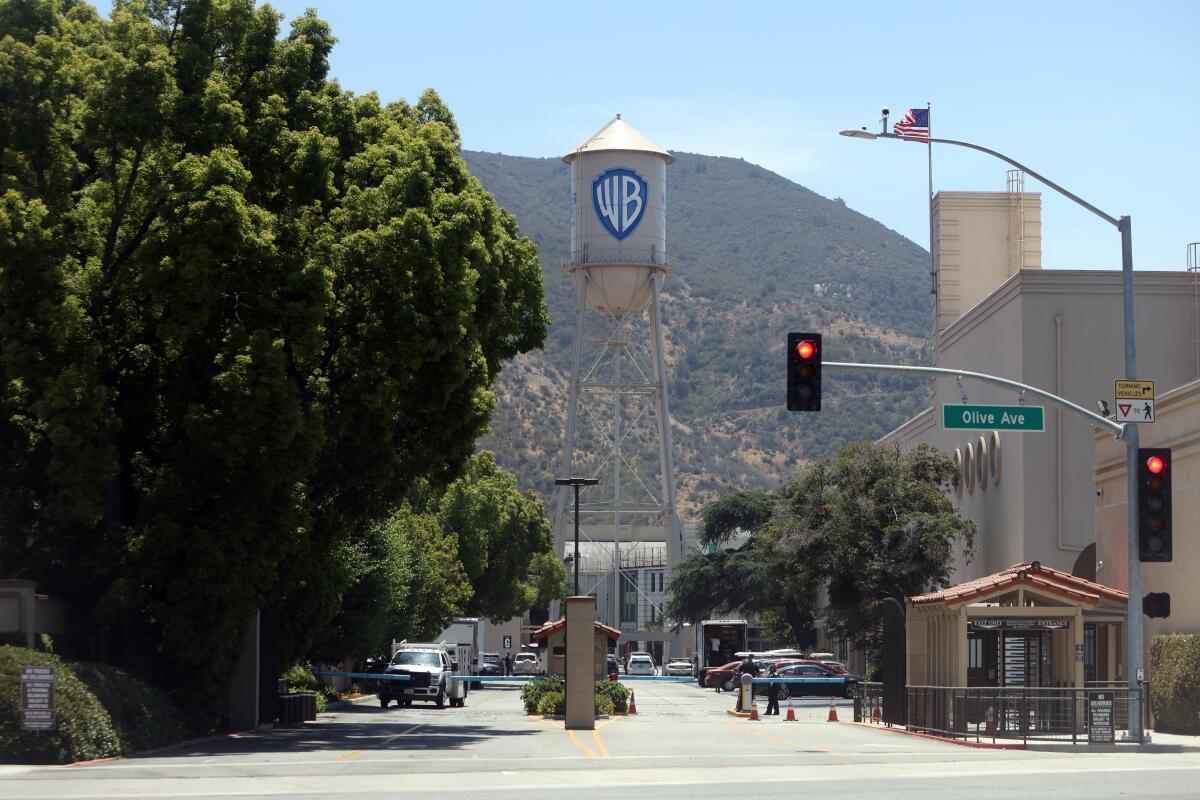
[{"xmin": 0, "ymin": 681, "xmax": 1200, "ymax": 800}]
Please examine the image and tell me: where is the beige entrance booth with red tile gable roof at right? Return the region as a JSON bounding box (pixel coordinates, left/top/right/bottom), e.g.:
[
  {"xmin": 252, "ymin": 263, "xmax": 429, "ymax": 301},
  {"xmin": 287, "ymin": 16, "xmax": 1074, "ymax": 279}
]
[{"xmin": 905, "ymin": 561, "xmax": 1128, "ymax": 738}]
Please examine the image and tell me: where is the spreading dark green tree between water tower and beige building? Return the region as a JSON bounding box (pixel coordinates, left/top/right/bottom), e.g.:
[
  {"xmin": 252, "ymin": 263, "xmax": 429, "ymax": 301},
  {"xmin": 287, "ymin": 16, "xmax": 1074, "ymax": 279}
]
[{"xmin": 668, "ymin": 443, "xmax": 976, "ymax": 646}]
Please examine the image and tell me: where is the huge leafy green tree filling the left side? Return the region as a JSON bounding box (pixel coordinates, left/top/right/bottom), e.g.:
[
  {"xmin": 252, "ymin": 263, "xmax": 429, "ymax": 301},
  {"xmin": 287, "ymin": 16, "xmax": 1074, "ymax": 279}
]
[{"xmin": 0, "ymin": 0, "xmax": 546, "ymax": 708}]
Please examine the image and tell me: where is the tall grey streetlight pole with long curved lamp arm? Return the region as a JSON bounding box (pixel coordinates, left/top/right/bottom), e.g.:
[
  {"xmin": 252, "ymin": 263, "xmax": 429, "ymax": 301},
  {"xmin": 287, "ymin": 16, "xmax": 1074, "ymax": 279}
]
[{"xmin": 841, "ymin": 128, "xmax": 1145, "ymax": 741}]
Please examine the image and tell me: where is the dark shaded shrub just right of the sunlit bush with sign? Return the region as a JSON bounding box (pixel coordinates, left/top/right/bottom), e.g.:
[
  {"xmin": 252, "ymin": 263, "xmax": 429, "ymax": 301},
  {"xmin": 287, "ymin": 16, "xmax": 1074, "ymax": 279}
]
[{"xmin": 71, "ymin": 661, "xmax": 192, "ymax": 756}]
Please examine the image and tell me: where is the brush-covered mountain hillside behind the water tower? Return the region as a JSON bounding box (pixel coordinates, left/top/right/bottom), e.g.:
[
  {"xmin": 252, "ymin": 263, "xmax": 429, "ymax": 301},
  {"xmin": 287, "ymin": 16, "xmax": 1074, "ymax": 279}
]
[{"xmin": 463, "ymin": 152, "xmax": 931, "ymax": 521}]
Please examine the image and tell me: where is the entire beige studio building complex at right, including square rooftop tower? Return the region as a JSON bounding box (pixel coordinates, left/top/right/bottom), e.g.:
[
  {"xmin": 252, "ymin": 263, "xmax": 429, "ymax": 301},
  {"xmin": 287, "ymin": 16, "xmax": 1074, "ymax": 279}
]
[{"xmin": 883, "ymin": 179, "xmax": 1200, "ymax": 685}]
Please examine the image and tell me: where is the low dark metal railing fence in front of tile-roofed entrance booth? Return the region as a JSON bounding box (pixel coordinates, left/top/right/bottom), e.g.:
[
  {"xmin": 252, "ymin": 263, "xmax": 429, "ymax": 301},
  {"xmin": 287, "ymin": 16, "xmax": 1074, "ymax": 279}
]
[{"xmin": 902, "ymin": 686, "xmax": 1146, "ymax": 744}]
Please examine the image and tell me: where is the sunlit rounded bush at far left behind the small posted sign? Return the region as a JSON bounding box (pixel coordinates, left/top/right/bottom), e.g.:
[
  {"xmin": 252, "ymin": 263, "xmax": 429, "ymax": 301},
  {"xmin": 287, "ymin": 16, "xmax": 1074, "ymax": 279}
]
[{"xmin": 0, "ymin": 645, "xmax": 121, "ymax": 764}]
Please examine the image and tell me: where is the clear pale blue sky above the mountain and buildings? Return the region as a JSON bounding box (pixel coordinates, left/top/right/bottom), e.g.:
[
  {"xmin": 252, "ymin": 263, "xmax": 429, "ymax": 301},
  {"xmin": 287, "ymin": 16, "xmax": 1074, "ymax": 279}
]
[{"xmin": 265, "ymin": 0, "xmax": 1200, "ymax": 270}]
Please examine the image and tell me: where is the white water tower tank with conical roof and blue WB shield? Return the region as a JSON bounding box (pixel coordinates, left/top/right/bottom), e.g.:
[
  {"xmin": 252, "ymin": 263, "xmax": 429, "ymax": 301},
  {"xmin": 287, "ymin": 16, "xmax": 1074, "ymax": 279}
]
[{"xmin": 563, "ymin": 114, "xmax": 674, "ymax": 318}]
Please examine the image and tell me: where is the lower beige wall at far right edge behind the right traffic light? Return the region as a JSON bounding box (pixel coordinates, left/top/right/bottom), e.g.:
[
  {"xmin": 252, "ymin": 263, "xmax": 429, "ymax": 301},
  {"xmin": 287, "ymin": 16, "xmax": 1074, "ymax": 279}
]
[{"xmin": 1093, "ymin": 379, "xmax": 1200, "ymax": 647}]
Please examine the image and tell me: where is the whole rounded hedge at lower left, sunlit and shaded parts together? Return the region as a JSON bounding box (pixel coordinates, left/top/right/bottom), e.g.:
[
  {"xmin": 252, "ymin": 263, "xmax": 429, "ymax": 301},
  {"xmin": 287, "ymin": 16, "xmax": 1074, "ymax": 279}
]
[{"xmin": 0, "ymin": 646, "xmax": 188, "ymax": 764}]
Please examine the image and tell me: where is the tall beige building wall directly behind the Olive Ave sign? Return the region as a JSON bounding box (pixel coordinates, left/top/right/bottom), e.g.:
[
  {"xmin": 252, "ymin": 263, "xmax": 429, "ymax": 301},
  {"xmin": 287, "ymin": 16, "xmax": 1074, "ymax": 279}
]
[{"xmin": 884, "ymin": 270, "xmax": 1192, "ymax": 585}]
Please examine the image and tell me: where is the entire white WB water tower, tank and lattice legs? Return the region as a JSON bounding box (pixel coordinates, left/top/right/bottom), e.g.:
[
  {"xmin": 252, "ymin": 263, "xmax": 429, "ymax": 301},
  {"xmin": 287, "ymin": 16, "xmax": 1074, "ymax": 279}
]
[{"xmin": 554, "ymin": 114, "xmax": 683, "ymax": 662}]
